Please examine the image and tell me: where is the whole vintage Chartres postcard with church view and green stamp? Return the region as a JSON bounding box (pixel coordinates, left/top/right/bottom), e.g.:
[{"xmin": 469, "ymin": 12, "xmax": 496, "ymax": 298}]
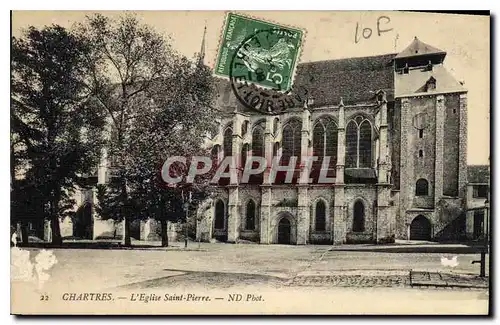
[{"xmin": 10, "ymin": 11, "xmax": 492, "ymax": 315}]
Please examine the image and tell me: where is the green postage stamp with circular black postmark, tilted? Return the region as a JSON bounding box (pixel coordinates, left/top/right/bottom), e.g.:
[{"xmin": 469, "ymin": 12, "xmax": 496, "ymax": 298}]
[{"xmin": 214, "ymin": 13, "xmax": 304, "ymax": 91}]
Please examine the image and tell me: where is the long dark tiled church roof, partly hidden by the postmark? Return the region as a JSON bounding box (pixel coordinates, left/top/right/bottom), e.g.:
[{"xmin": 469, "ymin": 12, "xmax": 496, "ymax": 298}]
[{"xmin": 213, "ymin": 54, "xmax": 396, "ymax": 112}]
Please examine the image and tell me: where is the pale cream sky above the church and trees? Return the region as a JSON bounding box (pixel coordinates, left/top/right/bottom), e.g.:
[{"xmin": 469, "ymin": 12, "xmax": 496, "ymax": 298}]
[{"xmin": 12, "ymin": 11, "xmax": 490, "ymax": 164}]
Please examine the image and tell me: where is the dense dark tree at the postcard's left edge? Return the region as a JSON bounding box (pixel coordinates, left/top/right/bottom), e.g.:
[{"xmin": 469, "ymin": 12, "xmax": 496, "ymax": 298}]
[{"xmin": 11, "ymin": 25, "xmax": 103, "ymax": 242}]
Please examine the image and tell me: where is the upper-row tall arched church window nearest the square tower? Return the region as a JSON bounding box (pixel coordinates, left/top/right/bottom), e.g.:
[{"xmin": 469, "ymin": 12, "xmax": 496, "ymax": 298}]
[{"xmin": 345, "ymin": 116, "xmax": 373, "ymax": 168}]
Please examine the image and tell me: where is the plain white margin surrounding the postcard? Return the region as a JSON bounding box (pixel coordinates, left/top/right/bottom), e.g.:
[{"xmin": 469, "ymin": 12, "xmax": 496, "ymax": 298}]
[{"xmin": 0, "ymin": 0, "xmax": 500, "ymax": 324}]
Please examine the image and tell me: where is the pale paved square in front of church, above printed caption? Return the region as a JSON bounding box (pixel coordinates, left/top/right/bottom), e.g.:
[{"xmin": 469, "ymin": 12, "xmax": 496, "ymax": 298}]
[{"xmin": 18, "ymin": 239, "xmax": 488, "ymax": 288}]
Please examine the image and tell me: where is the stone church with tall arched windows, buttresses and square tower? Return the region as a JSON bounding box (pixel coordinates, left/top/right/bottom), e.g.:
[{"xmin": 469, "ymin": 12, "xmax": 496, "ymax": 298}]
[{"xmin": 197, "ymin": 37, "xmax": 467, "ymax": 245}]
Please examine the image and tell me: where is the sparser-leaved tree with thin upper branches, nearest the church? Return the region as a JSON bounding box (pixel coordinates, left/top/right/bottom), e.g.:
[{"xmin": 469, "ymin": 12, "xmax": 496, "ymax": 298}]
[{"xmin": 77, "ymin": 14, "xmax": 215, "ymax": 245}]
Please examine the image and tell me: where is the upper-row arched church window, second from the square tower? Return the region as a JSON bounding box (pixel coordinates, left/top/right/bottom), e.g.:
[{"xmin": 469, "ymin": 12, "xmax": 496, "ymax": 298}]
[{"xmin": 313, "ymin": 117, "xmax": 338, "ymax": 168}]
